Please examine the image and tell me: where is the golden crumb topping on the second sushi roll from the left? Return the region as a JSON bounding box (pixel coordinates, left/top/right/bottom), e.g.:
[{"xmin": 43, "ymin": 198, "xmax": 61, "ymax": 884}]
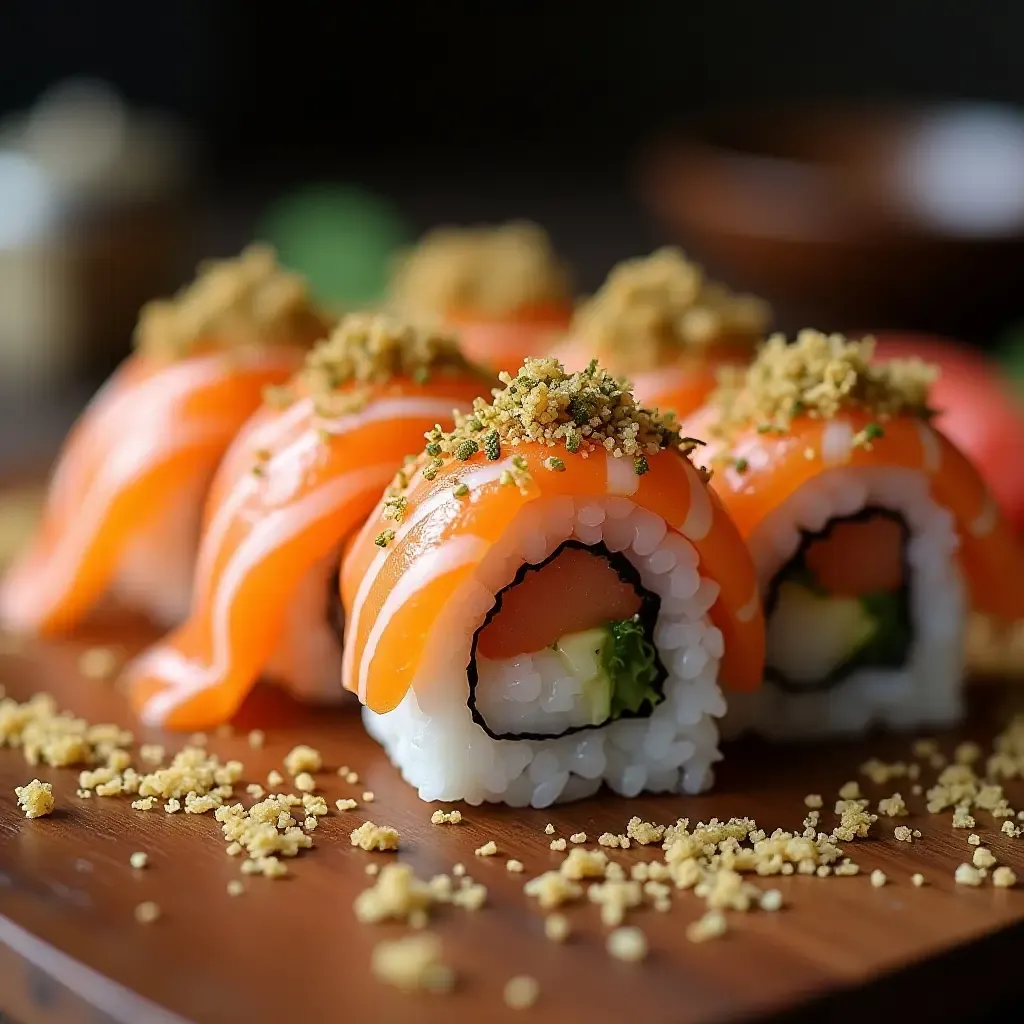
[{"xmin": 267, "ymin": 313, "xmax": 486, "ymax": 418}]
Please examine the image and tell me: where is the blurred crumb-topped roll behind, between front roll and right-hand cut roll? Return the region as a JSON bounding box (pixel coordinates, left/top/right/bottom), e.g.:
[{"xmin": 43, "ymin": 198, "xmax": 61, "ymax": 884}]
[{"xmin": 555, "ymin": 249, "xmax": 771, "ymax": 417}]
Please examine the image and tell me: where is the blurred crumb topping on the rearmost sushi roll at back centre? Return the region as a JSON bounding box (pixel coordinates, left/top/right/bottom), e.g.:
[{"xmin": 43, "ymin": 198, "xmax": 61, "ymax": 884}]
[{"xmin": 391, "ymin": 221, "xmax": 571, "ymax": 316}]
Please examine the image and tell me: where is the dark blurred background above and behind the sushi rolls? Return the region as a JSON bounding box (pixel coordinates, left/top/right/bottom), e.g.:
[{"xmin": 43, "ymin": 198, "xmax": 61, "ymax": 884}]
[{"xmin": 0, "ymin": 0, "xmax": 1024, "ymax": 465}]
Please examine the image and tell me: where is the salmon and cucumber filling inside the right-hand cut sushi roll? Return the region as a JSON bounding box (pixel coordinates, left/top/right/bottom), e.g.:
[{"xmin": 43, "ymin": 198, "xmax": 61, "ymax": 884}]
[{"xmin": 766, "ymin": 510, "xmax": 912, "ymax": 690}]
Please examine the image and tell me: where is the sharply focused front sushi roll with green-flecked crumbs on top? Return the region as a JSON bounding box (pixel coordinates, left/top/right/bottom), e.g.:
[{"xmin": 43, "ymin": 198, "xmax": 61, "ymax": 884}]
[{"xmin": 341, "ymin": 358, "xmax": 764, "ymax": 807}]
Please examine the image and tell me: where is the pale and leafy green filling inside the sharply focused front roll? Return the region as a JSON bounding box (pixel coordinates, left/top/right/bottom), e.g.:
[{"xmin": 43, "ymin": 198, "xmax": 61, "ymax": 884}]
[{"xmin": 551, "ymin": 615, "xmax": 662, "ymax": 725}]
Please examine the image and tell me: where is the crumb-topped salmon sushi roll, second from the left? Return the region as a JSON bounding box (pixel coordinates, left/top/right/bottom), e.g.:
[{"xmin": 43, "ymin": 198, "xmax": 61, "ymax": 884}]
[{"xmin": 127, "ymin": 314, "xmax": 494, "ymax": 729}]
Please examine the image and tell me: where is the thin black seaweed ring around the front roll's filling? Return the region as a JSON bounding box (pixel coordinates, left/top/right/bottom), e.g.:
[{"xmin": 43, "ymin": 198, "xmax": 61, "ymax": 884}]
[{"xmin": 466, "ymin": 541, "xmax": 669, "ymax": 740}]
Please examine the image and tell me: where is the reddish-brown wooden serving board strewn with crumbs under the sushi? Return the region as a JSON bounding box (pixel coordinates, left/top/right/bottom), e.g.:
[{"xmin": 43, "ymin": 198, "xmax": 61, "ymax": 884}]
[{"xmin": 0, "ymin": 624, "xmax": 1024, "ymax": 1024}]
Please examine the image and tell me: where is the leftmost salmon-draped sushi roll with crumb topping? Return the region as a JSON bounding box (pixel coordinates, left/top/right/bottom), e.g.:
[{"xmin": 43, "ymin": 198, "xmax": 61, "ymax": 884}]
[{"xmin": 0, "ymin": 246, "xmax": 326, "ymax": 634}]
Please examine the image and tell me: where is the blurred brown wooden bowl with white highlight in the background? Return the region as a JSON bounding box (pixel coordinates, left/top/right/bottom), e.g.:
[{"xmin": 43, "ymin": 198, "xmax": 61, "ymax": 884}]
[{"xmin": 641, "ymin": 104, "xmax": 1024, "ymax": 339}]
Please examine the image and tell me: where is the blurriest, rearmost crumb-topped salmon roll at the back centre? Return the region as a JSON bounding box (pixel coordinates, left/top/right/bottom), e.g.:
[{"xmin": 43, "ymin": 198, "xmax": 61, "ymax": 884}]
[{"xmin": 391, "ymin": 221, "xmax": 572, "ymax": 371}]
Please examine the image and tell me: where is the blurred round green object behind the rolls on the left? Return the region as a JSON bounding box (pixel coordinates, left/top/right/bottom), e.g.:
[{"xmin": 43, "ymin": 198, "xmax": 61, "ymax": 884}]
[{"xmin": 258, "ymin": 183, "xmax": 414, "ymax": 308}]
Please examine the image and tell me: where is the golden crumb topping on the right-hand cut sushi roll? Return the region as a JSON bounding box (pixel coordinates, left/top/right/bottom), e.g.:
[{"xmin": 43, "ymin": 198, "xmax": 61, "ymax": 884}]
[{"xmin": 711, "ymin": 331, "xmax": 936, "ymax": 444}]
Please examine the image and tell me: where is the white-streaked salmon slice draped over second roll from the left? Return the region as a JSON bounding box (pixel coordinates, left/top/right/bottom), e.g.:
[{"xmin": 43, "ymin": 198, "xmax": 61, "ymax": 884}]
[{"xmin": 127, "ymin": 373, "xmax": 481, "ymax": 730}]
